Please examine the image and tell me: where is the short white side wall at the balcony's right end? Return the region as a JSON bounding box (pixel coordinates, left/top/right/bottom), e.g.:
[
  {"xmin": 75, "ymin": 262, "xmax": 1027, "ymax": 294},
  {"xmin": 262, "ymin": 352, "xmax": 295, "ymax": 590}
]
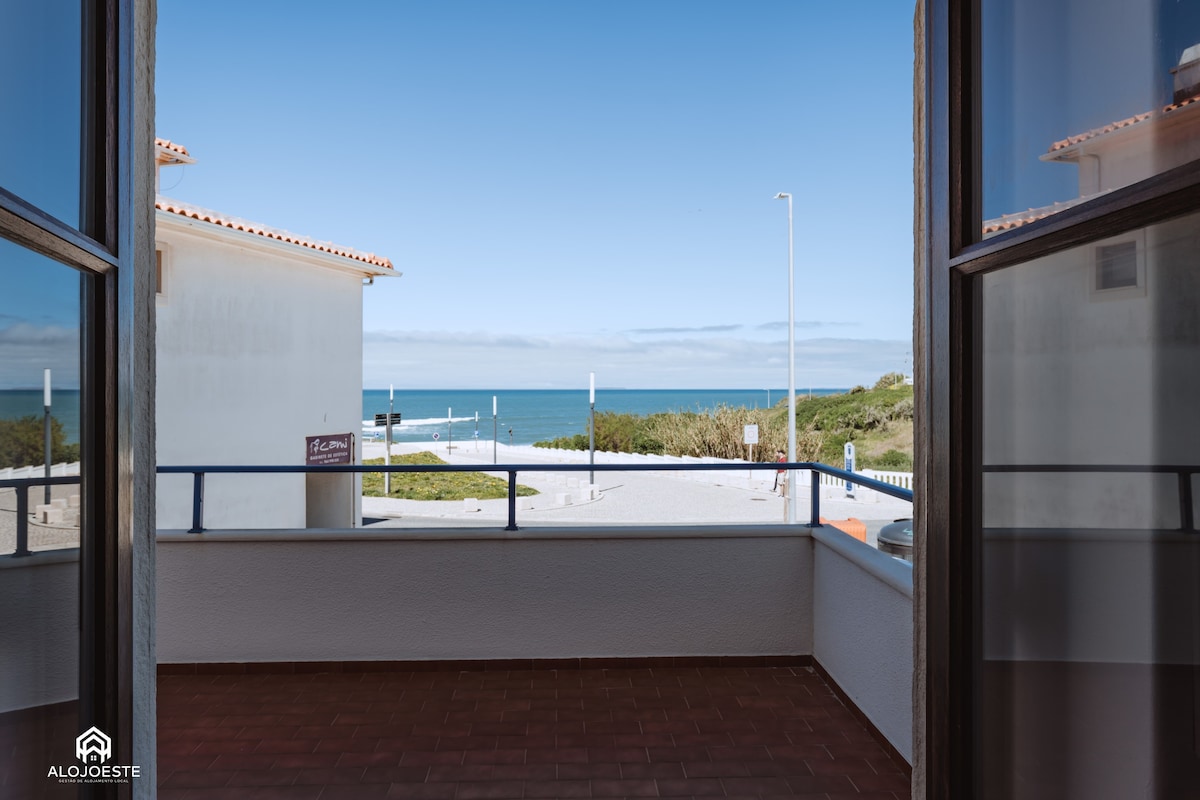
[{"xmin": 812, "ymin": 528, "xmax": 913, "ymax": 764}]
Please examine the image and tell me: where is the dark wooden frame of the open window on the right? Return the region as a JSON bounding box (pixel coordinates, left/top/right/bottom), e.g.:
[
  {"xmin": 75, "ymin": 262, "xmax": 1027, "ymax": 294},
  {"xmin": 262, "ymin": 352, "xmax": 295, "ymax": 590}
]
[{"xmin": 914, "ymin": 0, "xmax": 1200, "ymax": 800}]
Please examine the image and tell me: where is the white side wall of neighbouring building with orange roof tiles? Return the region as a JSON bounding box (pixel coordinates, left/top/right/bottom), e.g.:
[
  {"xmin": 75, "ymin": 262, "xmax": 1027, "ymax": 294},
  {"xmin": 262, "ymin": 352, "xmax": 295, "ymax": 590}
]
[{"xmin": 157, "ymin": 220, "xmax": 362, "ymax": 529}]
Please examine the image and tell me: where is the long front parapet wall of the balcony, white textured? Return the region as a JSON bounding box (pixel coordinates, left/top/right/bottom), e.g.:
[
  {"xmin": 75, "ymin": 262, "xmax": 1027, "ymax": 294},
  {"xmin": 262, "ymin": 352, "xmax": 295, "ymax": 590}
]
[{"xmin": 157, "ymin": 528, "xmax": 816, "ymax": 663}]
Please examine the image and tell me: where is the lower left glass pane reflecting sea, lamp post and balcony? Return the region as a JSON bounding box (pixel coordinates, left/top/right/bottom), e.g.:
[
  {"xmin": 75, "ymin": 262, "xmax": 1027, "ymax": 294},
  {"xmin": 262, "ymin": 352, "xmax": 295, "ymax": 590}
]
[{"xmin": 0, "ymin": 239, "xmax": 82, "ymax": 798}]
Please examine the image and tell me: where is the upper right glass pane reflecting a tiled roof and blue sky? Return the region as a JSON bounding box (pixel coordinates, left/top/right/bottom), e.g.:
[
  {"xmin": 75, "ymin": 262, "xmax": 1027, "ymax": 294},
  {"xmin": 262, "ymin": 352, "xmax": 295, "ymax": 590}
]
[{"xmin": 980, "ymin": 0, "xmax": 1200, "ymax": 237}]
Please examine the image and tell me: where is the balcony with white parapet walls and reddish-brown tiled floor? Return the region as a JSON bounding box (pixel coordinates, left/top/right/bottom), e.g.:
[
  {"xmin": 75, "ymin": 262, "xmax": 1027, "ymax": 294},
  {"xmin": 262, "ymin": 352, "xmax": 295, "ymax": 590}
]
[{"xmin": 0, "ymin": 465, "xmax": 913, "ymax": 800}]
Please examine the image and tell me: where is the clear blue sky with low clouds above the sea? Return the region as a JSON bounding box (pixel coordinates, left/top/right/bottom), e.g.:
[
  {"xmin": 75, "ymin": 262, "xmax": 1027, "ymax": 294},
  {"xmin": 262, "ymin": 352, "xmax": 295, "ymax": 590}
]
[{"xmin": 156, "ymin": 0, "xmax": 913, "ymax": 389}]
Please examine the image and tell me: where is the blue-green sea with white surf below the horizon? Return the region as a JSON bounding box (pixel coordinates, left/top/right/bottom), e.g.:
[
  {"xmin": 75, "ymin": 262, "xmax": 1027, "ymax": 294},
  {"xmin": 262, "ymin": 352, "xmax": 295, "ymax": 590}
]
[{"xmin": 362, "ymin": 387, "xmax": 847, "ymax": 445}]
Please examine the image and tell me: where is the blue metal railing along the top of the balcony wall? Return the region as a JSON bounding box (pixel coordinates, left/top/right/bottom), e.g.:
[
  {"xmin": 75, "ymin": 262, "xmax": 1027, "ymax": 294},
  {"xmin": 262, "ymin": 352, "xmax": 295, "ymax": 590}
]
[{"xmin": 154, "ymin": 462, "xmax": 912, "ymax": 534}]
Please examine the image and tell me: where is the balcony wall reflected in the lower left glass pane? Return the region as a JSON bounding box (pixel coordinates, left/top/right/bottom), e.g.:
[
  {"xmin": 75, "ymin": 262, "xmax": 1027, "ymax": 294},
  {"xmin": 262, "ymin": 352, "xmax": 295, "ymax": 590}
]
[{"xmin": 0, "ymin": 549, "xmax": 79, "ymax": 712}]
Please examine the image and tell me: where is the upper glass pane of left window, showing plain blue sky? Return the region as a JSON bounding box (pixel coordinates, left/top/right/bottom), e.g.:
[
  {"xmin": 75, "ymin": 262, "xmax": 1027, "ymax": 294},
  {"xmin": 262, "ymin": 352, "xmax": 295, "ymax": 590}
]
[{"xmin": 0, "ymin": 0, "xmax": 85, "ymax": 228}]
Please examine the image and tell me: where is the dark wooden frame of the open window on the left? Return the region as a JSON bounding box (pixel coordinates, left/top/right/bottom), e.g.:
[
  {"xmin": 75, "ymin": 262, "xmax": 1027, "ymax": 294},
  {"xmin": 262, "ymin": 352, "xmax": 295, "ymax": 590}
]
[{"xmin": 0, "ymin": 0, "xmax": 145, "ymax": 798}]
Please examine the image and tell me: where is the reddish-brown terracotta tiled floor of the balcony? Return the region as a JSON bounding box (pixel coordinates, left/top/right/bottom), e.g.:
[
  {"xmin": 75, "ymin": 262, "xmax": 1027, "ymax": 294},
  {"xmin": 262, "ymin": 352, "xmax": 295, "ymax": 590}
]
[{"xmin": 158, "ymin": 667, "xmax": 908, "ymax": 800}]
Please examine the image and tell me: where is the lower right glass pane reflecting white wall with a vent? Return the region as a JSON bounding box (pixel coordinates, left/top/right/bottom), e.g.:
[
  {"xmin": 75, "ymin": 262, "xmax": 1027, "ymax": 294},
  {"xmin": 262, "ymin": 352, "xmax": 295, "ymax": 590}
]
[{"xmin": 978, "ymin": 216, "xmax": 1200, "ymax": 800}]
